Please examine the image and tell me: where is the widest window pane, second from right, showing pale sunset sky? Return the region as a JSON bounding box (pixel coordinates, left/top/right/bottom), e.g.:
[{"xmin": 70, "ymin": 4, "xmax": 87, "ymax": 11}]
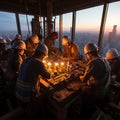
[{"xmin": 75, "ymin": 6, "xmax": 103, "ymax": 55}]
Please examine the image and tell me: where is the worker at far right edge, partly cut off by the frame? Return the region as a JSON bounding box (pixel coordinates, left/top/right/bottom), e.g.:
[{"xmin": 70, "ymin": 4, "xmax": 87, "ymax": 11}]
[{"xmin": 105, "ymin": 48, "xmax": 120, "ymax": 83}]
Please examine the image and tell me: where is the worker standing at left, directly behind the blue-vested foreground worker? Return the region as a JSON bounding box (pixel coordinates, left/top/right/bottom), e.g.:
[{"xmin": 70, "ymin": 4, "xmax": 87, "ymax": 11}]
[{"xmin": 6, "ymin": 40, "xmax": 26, "ymax": 108}]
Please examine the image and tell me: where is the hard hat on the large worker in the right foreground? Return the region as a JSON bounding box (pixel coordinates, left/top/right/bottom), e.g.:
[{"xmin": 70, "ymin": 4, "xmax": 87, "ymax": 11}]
[{"xmin": 84, "ymin": 43, "xmax": 98, "ymax": 54}]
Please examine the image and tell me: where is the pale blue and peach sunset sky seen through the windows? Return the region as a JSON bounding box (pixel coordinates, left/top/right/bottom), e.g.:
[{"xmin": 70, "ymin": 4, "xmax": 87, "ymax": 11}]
[{"xmin": 0, "ymin": 1, "xmax": 120, "ymax": 32}]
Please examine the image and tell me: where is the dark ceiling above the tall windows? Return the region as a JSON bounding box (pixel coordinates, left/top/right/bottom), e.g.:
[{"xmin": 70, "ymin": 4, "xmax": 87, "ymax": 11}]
[{"xmin": 0, "ymin": 0, "xmax": 120, "ymax": 16}]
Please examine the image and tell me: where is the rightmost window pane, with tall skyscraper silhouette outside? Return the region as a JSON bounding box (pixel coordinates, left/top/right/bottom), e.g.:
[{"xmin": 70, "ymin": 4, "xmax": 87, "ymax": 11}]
[{"xmin": 102, "ymin": 2, "xmax": 120, "ymax": 55}]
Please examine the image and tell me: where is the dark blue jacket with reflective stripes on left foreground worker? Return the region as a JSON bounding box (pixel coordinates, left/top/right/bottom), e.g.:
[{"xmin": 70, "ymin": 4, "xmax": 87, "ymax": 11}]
[{"xmin": 16, "ymin": 58, "xmax": 50, "ymax": 102}]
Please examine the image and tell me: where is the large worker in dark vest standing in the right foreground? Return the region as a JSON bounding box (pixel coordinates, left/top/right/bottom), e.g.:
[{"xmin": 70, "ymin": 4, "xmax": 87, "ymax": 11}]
[{"xmin": 80, "ymin": 43, "xmax": 110, "ymax": 120}]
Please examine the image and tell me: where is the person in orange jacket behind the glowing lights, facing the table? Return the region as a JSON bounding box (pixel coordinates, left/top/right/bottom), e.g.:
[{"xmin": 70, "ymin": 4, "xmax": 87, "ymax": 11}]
[{"xmin": 61, "ymin": 36, "xmax": 80, "ymax": 61}]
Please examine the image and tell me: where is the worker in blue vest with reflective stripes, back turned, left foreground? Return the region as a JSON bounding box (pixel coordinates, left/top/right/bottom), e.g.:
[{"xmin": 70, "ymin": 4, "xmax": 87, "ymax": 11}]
[{"xmin": 16, "ymin": 44, "xmax": 50, "ymax": 120}]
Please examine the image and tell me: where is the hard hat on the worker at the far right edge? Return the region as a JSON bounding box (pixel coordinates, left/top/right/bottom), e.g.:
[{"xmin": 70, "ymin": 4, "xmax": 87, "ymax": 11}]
[{"xmin": 105, "ymin": 48, "xmax": 120, "ymax": 60}]
